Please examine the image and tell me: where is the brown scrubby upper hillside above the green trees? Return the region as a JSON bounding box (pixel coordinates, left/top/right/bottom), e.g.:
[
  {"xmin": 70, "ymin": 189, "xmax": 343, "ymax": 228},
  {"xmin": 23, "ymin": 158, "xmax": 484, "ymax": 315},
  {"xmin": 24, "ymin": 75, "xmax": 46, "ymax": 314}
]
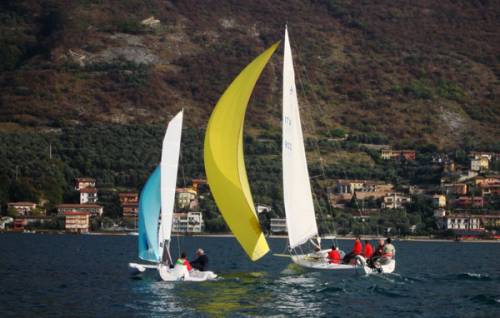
[{"xmin": 0, "ymin": 0, "xmax": 500, "ymax": 149}]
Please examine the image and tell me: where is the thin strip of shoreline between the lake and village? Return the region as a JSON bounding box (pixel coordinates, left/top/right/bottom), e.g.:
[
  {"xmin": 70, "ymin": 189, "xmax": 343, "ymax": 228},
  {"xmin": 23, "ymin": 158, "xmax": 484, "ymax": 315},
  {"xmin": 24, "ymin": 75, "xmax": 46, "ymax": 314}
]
[{"xmin": 0, "ymin": 230, "xmax": 500, "ymax": 243}]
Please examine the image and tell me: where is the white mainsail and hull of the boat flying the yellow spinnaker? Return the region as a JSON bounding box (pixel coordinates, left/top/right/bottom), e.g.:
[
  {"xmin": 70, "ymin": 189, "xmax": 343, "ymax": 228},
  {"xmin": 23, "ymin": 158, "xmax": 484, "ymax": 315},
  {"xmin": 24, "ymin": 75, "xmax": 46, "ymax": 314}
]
[{"xmin": 282, "ymin": 29, "xmax": 395, "ymax": 273}]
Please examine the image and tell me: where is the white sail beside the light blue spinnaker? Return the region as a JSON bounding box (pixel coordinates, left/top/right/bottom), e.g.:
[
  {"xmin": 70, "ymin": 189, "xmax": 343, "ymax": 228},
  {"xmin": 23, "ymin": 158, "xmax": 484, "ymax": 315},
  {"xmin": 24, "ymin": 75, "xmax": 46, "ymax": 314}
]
[{"xmin": 158, "ymin": 110, "xmax": 183, "ymax": 256}]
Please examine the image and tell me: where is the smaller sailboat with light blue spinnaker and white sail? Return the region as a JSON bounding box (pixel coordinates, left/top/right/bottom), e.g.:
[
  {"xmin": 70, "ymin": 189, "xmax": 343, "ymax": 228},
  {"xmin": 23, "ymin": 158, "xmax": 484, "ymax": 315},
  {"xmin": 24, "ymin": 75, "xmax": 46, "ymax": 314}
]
[{"xmin": 129, "ymin": 111, "xmax": 217, "ymax": 281}]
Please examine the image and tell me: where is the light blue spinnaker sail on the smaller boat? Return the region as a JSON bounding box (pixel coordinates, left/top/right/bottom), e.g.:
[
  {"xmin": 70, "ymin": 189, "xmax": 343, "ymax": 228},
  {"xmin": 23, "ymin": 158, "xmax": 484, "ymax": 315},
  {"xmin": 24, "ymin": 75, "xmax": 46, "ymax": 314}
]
[{"xmin": 139, "ymin": 166, "xmax": 161, "ymax": 262}]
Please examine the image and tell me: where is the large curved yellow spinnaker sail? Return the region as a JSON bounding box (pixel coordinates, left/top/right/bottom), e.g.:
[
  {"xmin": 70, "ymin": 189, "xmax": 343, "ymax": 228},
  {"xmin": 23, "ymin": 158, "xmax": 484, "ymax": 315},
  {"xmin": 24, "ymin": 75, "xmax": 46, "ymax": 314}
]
[{"xmin": 204, "ymin": 42, "xmax": 279, "ymax": 261}]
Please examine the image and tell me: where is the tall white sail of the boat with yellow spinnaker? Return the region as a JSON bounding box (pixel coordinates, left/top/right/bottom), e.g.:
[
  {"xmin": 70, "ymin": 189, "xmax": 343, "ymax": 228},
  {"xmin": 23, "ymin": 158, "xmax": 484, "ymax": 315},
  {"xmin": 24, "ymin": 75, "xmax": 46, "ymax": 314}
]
[{"xmin": 282, "ymin": 29, "xmax": 318, "ymax": 248}]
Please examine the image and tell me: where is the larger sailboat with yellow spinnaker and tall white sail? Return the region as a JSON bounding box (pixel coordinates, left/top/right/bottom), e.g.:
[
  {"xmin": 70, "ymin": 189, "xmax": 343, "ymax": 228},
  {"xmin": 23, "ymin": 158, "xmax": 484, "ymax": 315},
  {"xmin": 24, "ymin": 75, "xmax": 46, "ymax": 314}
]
[{"xmin": 205, "ymin": 29, "xmax": 394, "ymax": 272}]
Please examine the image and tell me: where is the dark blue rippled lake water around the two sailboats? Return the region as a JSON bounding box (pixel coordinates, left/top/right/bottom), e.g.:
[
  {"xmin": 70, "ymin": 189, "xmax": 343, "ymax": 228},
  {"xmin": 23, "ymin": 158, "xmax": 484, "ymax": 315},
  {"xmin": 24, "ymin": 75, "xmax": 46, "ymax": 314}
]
[{"xmin": 0, "ymin": 233, "xmax": 500, "ymax": 317}]
